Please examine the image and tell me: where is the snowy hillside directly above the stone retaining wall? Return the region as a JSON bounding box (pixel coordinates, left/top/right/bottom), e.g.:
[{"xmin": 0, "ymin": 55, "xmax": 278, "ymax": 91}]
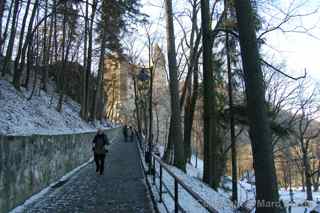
[{"xmin": 0, "ymin": 80, "xmax": 112, "ymax": 135}]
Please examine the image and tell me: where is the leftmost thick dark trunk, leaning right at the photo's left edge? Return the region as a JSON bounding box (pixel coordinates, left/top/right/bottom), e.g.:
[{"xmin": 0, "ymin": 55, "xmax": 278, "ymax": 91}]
[{"xmin": 2, "ymin": 0, "xmax": 20, "ymax": 76}]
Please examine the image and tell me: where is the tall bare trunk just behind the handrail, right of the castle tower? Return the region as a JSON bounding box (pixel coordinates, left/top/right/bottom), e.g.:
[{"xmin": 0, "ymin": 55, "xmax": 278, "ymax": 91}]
[{"xmin": 165, "ymin": 0, "xmax": 185, "ymax": 171}]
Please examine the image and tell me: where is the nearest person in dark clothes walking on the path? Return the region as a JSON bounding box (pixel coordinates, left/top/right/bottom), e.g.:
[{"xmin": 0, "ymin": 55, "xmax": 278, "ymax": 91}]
[{"xmin": 92, "ymin": 129, "xmax": 110, "ymax": 175}]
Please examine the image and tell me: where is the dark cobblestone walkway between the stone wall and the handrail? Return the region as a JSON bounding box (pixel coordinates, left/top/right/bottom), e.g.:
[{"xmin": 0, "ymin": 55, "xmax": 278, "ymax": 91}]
[{"xmin": 23, "ymin": 142, "xmax": 153, "ymax": 213}]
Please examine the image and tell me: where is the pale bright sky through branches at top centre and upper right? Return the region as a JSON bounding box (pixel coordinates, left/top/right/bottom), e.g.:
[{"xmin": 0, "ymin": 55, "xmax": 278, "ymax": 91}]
[{"xmin": 139, "ymin": 0, "xmax": 320, "ymax": 82}]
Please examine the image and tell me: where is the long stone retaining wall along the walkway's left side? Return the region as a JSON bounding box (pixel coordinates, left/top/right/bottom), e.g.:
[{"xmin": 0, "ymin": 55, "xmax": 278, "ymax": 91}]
[{"xmin": 0, "ymin": 128, "xmax": 123, "ymax": 213}]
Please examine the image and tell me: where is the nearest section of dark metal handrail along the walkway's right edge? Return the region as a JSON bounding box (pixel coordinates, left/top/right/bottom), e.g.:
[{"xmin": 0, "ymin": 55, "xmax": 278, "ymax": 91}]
[{"xmin": 150, "ymin": 153, "xmax": 218, "ymax": 213}]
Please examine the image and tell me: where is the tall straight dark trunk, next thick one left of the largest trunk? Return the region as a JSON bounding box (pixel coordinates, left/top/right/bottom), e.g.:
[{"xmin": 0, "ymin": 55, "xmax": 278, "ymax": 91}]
[{"xmin": 201, "ymin": 0, "xmax": 220, "ymax": 189}]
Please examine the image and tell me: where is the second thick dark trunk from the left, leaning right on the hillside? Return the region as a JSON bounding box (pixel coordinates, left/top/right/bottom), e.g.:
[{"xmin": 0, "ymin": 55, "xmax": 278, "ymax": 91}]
[{"xmin": 13, "ymin": 0, "xmax": 31, "ymax": 90}]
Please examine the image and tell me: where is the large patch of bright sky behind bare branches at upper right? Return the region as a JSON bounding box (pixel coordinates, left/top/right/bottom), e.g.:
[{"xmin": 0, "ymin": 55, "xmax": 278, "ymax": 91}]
[{"xmin": 264, "ymin": 0, "xmax": 320, "ymax": 82}]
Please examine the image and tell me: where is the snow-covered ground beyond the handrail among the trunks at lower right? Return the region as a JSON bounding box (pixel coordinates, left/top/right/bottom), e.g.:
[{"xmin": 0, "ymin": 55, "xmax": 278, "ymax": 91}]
[{"xmin": 150, "ymin": 146, "xmax": 320, "ymax": 213}]
